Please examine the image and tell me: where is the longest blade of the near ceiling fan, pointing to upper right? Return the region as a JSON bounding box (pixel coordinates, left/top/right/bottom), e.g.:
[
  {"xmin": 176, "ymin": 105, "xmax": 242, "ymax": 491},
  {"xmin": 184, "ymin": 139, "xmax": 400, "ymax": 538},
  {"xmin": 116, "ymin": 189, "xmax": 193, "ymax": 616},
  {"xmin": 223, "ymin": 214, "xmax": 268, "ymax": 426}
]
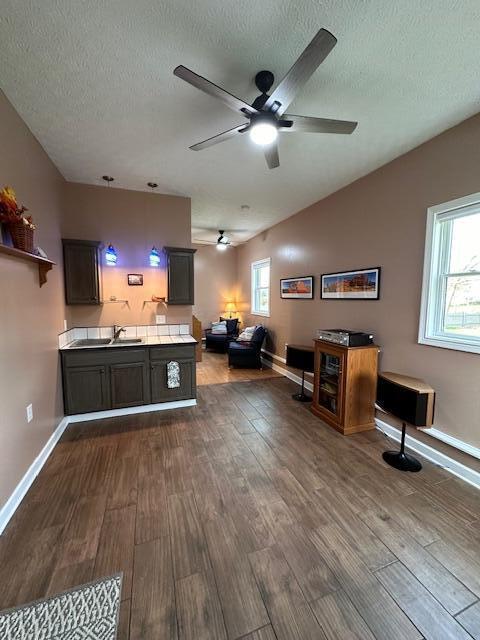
[{"xmin": 263, "ymin": 29, "xmax": 337, "ymax": 115}]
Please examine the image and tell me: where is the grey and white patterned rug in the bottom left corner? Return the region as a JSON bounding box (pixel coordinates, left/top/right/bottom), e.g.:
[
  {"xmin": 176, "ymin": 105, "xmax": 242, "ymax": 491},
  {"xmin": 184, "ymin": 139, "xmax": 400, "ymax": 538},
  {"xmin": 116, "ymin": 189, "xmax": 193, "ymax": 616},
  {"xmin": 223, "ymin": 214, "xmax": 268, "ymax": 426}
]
[{"xmin": 0, "ymin": 574, "xmax": 122, "ymax": 640}]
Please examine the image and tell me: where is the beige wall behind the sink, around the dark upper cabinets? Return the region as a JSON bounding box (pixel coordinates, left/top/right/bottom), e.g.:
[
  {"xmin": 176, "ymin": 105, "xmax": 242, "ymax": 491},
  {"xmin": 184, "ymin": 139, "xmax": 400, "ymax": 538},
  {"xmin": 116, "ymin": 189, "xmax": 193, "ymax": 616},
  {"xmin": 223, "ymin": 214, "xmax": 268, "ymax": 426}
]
[{"xmin": 62, "ymin": 183, "xmax": 192, "ymax": 327}]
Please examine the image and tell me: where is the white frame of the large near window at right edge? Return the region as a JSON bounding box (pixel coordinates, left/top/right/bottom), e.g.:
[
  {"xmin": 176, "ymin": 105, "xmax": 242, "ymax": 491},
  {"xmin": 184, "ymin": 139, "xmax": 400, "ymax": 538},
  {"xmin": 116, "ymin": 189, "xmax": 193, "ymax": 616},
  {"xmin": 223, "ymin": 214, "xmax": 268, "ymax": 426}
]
[{"xmin": 418, "ymin": 193, "xmax": 480, "ymax": 353}]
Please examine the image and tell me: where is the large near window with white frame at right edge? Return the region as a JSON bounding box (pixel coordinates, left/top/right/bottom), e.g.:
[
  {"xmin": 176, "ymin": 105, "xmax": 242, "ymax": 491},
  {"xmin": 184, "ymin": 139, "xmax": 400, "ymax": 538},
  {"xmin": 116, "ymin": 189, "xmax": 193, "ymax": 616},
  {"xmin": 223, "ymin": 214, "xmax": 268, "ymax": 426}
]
[{"xmin": 418, "ymin": 193, "xmax": 480, "ymax": 353}]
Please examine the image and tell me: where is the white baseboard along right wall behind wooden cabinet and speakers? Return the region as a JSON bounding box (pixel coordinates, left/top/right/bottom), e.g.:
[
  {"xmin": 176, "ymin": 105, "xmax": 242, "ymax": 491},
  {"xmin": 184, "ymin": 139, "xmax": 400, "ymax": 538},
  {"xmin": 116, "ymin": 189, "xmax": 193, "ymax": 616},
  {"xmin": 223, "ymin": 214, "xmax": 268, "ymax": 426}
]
[{"xmin": 262, "ymin": 349, "xmax": 480, "ymax": 489}]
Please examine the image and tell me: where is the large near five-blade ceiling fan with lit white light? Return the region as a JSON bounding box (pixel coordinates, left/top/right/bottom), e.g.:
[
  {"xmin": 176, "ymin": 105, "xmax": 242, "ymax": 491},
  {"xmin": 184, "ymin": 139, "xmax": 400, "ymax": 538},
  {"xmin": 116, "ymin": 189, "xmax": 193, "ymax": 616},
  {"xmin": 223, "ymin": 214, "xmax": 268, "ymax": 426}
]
[{"xmin": 173, "ymin": 29, "xmax": 358, "ymax": 169}]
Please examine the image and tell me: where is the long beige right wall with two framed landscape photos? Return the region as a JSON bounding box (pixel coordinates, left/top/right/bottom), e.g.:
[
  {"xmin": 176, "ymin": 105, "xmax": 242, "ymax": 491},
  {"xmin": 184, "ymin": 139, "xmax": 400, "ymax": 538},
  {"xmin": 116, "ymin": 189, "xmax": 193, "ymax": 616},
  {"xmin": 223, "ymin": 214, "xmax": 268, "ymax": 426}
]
[{"xmin": 238, "ymin": 116, "xmax": 480, "ymax": 447}]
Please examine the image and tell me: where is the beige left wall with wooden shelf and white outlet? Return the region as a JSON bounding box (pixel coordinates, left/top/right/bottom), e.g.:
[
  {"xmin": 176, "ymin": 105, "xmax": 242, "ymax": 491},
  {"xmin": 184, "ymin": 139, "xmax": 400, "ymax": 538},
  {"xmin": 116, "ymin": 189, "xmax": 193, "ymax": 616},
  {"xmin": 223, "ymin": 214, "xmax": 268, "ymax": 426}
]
[{"xmin": 0, "ymin": 92, "xmax": 64, "ymax": 507}]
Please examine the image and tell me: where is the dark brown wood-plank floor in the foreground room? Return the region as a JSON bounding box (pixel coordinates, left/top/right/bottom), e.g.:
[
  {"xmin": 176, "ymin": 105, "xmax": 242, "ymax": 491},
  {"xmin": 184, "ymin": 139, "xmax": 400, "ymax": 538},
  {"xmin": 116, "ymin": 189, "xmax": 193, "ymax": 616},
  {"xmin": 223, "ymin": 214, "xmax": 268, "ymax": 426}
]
[{"xmin": 0, "ymin": 377, "xmax": 480, "ymax": 640}]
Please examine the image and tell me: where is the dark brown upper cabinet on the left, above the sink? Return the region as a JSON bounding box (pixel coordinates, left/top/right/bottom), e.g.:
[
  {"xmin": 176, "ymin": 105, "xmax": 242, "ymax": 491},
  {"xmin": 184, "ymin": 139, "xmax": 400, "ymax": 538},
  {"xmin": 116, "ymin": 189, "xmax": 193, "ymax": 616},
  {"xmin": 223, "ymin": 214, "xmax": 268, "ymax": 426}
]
[{"xmin": 62, "ymin": 239, "xmax": 101, "ymax": 304}]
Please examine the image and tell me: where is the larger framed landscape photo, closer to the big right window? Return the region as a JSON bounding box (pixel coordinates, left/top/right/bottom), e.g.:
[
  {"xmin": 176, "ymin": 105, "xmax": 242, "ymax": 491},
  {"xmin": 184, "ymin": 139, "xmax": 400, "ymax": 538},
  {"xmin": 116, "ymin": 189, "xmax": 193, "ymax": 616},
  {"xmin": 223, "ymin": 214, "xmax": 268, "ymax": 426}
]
[{"xmin": 320, "ymin": 267, "xmax": 380, "ymax": 300}]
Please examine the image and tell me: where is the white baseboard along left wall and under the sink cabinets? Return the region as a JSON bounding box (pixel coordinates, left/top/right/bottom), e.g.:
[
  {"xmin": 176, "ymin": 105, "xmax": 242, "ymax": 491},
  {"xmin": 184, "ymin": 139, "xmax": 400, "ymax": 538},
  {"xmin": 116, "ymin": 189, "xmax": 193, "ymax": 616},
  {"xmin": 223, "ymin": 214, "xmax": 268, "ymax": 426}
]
[{"xmin": 0, "ymin": 399, "xmax": 197, "ymax": 536}]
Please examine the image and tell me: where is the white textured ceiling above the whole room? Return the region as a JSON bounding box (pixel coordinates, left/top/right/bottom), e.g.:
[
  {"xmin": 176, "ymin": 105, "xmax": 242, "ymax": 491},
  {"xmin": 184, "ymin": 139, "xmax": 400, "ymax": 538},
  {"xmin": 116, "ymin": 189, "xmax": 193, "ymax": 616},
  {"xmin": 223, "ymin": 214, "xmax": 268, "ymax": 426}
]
[{"xmin": 0, "ymin": 0, "xmax": 480, "ymax": 241}]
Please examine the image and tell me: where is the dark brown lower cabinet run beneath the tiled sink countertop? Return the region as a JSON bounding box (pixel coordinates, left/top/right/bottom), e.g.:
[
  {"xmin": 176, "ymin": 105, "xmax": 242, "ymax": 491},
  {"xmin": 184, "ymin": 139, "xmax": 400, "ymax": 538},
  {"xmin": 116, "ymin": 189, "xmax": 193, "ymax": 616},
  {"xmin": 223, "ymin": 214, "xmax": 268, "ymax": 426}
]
[{"xmin": 61, "ymin": 344, "xmax": 196, "ymax": 415}]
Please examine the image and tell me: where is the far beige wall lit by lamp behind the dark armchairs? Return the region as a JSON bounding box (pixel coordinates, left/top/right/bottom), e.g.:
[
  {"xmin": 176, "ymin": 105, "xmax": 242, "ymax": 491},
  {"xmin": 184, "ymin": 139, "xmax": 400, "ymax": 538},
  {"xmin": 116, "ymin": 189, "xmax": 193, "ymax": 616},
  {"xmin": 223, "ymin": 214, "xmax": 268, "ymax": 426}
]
[{"xmin": 193, "ymin": 244, "xmax": 238, "ymax": 329}]
